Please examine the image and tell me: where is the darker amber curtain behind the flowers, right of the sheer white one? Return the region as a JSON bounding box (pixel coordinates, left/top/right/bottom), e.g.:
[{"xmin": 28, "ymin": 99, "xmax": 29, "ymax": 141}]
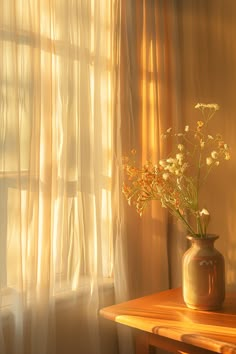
[{"xmin": 121, "ymin": 1, "xmax": 183, "ymax": 297}]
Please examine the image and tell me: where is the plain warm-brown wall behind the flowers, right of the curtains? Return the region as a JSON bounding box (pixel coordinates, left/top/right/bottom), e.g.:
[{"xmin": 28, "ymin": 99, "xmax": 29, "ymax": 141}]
[{"xmin": 172, "ymin": 0, "xmax": 236, "ymax": 289}]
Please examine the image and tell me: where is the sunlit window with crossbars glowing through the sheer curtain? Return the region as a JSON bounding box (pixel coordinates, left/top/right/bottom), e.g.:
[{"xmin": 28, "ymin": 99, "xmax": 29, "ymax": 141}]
[{"xmin": 0, "ymin": 0, "xmax": 116, "ymax": 304}]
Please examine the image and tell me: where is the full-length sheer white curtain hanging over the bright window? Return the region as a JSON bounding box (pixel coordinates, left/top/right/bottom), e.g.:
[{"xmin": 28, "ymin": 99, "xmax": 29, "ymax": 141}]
[{"xmin": 0, "ymin": 0, "xmax": 119, "ymax": 354}]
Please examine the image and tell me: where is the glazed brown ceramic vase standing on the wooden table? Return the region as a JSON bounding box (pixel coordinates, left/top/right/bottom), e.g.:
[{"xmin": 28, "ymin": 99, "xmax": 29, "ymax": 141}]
[{"xmin": 182, "ymin": 235, "xmax": 225, "ymax": 311}]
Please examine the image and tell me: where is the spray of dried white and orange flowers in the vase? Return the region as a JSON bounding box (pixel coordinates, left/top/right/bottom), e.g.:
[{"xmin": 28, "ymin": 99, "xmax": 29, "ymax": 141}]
[{"xmin": 122, "ymin": 103, "xmax": 230, "ymax": 237}]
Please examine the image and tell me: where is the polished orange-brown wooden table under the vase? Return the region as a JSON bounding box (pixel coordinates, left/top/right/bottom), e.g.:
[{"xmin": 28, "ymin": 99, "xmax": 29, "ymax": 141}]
[{"xmin": 100, "ymin": 289, "xmax": 236, "ymax": 354}]
